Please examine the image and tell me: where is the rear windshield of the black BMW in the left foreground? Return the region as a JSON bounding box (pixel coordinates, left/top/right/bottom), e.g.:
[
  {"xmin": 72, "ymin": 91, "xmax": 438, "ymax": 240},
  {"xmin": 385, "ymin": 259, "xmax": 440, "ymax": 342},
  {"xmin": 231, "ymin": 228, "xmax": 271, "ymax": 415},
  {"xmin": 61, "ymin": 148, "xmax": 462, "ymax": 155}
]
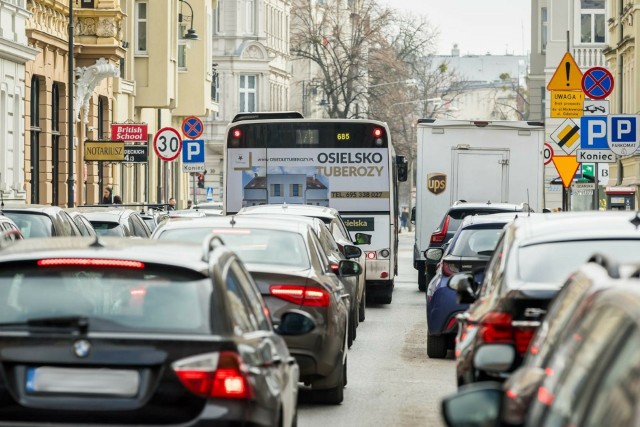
[{"xmin": 0, "ymin": 259, "xmax": 215, "ymax": 334}]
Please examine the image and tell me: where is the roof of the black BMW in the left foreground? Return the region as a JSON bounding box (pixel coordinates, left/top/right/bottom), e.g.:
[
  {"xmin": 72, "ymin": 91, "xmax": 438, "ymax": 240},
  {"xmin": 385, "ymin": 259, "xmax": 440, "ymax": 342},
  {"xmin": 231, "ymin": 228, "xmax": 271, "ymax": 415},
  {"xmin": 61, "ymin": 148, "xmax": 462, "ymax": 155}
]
[{"xmin": 0, "ymin": 237, "xmax": 207, "ymax": 271}]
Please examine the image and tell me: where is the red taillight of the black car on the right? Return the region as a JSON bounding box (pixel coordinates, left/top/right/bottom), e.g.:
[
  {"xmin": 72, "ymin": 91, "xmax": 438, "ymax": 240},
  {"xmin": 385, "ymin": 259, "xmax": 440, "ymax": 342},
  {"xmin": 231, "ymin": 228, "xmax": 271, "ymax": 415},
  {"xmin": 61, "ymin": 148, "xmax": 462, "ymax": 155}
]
[{"xmin": 480, "ymin": 311, "xmax": 536, "ymax": 355}]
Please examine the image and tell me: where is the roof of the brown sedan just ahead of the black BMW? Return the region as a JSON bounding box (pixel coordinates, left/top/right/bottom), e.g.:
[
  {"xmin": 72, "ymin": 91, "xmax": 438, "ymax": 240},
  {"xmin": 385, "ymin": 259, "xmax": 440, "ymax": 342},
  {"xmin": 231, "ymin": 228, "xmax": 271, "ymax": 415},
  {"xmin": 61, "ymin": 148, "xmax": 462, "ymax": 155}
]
[{"xmin": 154, "ymin": 215, "xmax": 316, "ymax": 234}]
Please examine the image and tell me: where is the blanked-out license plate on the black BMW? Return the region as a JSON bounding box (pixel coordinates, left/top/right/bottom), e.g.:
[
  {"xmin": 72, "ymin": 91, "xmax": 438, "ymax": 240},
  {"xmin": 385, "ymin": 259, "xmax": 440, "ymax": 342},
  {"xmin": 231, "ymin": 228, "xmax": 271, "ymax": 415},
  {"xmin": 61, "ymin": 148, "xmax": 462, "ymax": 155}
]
[{"xmin": 26, "ymin": 366, "xmax": 140, "ymax": 397}]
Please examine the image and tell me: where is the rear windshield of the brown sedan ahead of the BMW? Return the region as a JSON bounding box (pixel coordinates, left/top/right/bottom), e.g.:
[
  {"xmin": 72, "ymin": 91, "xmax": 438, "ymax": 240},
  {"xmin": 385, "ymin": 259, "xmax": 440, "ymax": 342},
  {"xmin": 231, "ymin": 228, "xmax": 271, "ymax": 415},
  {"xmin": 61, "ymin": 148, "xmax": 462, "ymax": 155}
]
[{"xmin": 158, "ymin": 227, "xmax": 310, "ymax": 269}]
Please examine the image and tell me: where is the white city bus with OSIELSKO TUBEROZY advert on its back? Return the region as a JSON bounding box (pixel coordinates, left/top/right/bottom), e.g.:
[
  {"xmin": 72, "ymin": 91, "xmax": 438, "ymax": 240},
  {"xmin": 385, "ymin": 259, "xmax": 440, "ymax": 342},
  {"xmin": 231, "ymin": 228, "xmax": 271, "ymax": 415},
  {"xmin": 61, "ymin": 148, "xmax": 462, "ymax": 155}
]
[{"xmin": 224, "ymin": 113, "xmax": 407, "ymax": 304}]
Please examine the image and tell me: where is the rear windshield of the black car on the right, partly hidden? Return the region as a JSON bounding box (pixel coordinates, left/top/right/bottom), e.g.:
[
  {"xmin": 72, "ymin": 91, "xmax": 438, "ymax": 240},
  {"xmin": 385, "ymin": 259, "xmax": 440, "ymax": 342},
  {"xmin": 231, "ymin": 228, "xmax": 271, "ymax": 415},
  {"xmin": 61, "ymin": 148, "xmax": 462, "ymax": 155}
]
[{"xmin": 507, "ymin": 239, "xmax": 640, "ymax": 285}]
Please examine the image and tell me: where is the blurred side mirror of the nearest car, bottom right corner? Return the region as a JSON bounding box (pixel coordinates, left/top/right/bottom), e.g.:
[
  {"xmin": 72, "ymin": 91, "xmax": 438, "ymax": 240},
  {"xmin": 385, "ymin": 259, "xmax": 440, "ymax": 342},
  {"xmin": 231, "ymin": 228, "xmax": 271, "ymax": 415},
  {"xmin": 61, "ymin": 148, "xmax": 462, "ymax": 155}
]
[{"xmin": 442, "ymin": 381, "xmax": 503, "ymax": 427}]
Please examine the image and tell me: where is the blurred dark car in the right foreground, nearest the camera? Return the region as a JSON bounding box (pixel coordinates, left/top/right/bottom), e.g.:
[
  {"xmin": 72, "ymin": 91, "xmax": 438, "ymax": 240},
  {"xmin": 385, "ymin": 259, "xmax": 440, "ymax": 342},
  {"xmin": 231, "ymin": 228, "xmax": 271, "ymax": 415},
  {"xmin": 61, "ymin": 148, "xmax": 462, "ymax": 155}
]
[{"xmin": 442, "ymin": 262, "xmax": 640, "ymax": 427}]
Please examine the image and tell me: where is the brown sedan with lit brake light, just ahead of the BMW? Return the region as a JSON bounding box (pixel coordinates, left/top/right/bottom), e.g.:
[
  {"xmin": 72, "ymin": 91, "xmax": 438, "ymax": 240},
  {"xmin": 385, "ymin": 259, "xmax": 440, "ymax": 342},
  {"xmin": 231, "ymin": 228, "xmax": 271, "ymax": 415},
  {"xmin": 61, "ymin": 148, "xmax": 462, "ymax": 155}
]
[{"xmin": 152, "ymin": 215, "xmax": 361, "ymax": 404}]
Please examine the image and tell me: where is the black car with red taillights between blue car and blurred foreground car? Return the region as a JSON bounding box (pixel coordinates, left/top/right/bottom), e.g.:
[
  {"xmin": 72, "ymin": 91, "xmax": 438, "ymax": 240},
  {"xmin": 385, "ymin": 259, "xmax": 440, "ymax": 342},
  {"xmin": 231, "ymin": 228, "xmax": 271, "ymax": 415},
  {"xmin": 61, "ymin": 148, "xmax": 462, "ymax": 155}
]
[{"xmin": 449, "ymin": 212, "xmax": 640, "ymax": 385}]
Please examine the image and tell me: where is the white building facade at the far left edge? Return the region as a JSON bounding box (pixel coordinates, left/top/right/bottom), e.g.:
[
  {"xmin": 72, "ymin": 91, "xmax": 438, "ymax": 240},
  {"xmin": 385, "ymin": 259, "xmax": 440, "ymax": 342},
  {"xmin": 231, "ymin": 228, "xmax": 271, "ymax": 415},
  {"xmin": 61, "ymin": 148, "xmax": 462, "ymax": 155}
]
[{"xmin": 0, "ymin": 0, "xmax": 38, "ymax": 203}]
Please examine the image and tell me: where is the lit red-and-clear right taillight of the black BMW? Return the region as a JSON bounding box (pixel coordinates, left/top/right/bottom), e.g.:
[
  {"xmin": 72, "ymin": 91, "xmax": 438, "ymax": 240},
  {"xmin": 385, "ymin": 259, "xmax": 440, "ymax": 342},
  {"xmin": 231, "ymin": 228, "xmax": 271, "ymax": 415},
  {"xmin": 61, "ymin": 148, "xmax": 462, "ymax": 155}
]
[{"xmin": 172, "ymin": 351, "xmax": 253, "ymax": 399}]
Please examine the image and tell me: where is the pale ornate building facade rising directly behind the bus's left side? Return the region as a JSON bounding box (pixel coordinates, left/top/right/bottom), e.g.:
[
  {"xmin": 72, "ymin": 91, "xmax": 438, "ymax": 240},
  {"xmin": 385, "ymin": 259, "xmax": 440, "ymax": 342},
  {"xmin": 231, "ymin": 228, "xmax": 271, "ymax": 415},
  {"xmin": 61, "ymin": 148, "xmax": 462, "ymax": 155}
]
[{"xmin": 201, "ymin": 0, "xmax": 291, "ymax": 201}]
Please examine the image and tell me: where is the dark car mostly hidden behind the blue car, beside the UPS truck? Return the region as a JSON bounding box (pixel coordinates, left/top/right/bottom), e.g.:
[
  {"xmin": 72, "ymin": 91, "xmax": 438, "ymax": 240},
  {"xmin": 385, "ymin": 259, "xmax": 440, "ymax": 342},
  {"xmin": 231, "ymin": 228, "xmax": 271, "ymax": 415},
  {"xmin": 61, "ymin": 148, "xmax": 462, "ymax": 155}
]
[{"xmin": 412, "ymin": 201, "xmax": 529, "ymax": 291}]
